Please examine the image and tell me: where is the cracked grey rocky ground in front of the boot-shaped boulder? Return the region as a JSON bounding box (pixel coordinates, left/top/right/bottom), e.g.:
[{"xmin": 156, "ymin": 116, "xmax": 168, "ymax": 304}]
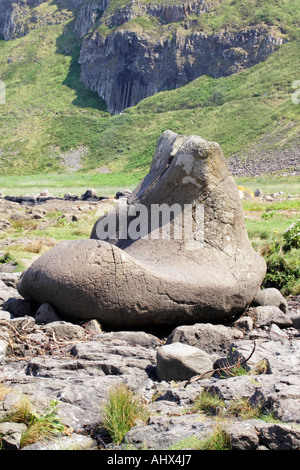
[{"xmin": 0, "ymin": 273, "xmax": 300, "ymax": 450}]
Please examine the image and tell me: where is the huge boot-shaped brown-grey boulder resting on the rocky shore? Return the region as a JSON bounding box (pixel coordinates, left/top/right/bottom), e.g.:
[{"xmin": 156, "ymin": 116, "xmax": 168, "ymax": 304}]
[{"xmin": 18, "ymin": 131, "xmax": 266, "ymax": 329}]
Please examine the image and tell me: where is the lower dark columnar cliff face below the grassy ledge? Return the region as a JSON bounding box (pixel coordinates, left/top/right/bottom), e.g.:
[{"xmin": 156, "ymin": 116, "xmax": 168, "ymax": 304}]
[{"xmin": 80, "ymin": 28, "xmax": 282, "ymax": 114}]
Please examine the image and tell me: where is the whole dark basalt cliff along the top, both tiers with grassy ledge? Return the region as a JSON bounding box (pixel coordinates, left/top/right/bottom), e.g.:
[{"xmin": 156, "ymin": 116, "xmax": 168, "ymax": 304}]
[{"xmin": 0, "ymin": 0, "xmax": 284, "ymax": 114}]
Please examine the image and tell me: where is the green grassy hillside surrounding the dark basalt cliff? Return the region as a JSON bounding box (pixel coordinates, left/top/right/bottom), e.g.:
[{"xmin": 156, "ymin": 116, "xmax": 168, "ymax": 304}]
[{"xmin": 0, "ymin": 0, "xmax": 300, "ymax": 176}]
